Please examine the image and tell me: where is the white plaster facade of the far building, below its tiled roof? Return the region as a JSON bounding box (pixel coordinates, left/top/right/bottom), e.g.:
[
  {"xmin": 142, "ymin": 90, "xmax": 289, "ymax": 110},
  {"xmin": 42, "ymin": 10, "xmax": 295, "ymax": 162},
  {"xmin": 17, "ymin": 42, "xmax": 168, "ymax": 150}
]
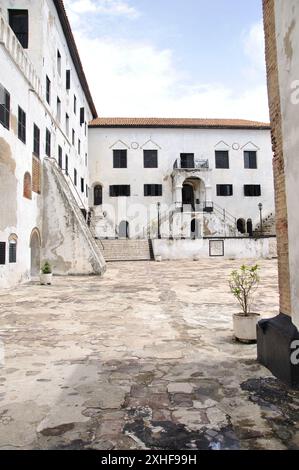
[{"xmin": 89, "ymin": 128, "xmax": 274, "ymax": 237}]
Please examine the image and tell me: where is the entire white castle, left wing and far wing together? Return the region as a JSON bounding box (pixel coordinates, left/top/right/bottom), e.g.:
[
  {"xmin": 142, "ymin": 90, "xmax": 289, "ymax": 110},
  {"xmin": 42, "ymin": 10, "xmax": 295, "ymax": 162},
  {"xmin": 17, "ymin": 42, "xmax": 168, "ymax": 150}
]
[{"xmin": 0, "ymin": 0, "xmax": 274, "ymax": 288}]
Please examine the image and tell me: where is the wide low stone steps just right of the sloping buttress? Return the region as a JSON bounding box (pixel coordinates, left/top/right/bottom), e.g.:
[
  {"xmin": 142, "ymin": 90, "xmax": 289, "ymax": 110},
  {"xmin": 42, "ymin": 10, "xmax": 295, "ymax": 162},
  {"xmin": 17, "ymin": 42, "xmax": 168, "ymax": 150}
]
[{"xmin": 97, "ymin": 240, "xmax": 154, "ymax": 262}]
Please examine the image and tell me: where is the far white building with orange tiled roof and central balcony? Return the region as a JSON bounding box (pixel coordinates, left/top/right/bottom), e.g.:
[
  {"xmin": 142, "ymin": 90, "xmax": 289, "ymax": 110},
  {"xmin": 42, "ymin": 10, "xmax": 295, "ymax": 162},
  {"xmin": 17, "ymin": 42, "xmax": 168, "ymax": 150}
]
[{"xmin": 89, "ymin": 118, "xmax": 274, "ymax": 257}]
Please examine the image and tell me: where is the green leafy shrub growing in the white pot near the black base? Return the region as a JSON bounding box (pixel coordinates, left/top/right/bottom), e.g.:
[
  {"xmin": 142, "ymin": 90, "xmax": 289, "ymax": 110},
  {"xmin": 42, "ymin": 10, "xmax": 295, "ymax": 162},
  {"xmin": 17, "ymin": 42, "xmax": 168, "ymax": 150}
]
[{"xmin": 229, "ymin": 264, "xmax": 260, "ymax": 316}]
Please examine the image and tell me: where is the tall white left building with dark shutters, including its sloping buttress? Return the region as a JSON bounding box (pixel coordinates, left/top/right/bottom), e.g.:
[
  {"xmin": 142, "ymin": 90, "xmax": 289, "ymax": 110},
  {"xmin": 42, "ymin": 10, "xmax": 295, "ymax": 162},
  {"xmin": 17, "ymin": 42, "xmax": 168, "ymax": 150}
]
[{"xmin": 0, "ymin": 0, "xmax": 105, "ymax": 287}]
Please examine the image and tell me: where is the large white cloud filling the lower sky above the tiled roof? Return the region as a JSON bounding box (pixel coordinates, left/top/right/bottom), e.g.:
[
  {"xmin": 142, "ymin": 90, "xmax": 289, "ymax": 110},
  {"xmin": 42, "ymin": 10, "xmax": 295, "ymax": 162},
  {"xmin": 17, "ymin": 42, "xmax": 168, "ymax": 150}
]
[{"xmin": 69, "ymin": 11, "xmax": 269, "ymax": 121}]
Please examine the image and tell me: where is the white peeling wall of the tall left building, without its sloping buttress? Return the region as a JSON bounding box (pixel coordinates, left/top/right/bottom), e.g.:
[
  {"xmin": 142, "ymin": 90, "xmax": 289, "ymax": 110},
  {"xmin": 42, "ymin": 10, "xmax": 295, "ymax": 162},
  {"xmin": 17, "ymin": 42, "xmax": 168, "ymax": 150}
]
[{"xmin": 0, "ymin": 0, "xmax": 92, "ymax": 289}]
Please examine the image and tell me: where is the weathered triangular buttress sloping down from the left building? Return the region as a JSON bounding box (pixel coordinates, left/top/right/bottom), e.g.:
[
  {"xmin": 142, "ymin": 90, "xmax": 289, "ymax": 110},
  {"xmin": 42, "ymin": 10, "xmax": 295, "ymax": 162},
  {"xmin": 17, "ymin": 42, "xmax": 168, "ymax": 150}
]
[{"xmin": 43, "ymin": 159, "xmax": 105, "ymax": 275}]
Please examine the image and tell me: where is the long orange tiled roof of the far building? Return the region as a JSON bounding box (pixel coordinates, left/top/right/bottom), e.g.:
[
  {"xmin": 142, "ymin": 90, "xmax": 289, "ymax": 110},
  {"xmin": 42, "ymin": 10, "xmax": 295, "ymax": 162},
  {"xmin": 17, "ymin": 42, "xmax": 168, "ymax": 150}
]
[{"xmin": 89, "ymin": 117, "xmax": 270, "ymax": 129}]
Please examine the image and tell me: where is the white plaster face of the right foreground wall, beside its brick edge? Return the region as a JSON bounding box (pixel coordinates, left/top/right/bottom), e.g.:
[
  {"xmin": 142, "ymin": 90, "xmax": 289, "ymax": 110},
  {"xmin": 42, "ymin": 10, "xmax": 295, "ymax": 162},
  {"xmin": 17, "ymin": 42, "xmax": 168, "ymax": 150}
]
[{"xmin": 269, "ymin": 0, "xmax": 299, "ymax": 328}]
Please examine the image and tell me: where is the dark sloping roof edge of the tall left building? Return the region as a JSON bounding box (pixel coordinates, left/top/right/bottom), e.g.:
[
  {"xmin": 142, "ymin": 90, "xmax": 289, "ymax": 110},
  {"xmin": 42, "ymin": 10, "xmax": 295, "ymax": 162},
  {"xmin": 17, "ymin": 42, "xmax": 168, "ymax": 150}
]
[{"xmin": 54, "ymin": 0, "xmax": 98, "ymax": 118}]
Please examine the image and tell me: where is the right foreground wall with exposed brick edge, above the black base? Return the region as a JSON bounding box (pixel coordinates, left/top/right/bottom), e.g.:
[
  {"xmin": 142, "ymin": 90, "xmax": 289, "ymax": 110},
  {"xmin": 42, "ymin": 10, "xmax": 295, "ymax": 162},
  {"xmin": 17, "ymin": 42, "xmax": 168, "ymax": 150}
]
[{"xmin": 264, "ymin": 0, "xmax": 299, "ymax": 327}]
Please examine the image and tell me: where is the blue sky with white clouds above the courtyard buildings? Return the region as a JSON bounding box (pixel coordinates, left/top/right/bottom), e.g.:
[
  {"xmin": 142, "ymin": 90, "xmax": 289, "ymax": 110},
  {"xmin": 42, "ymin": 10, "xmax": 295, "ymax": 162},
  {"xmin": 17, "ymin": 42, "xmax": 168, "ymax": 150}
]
[{"xmin": 65, "ymin": 0, "xmax": 269, "ymax": 121}]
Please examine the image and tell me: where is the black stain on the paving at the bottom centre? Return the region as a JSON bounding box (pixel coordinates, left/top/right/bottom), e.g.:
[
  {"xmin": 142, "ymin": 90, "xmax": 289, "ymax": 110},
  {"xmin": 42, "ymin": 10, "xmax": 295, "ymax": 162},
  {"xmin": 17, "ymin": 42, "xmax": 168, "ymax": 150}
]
[{"xmin": 124, "ymin": 419, "xmax": 239, "ymax": 450}]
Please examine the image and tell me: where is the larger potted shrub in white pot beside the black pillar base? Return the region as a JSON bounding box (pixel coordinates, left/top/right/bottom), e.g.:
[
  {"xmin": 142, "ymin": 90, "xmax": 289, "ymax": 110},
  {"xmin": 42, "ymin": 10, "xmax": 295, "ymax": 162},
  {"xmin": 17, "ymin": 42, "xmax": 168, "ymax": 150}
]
[{"xmin": 229, "ymin": 265, "xmax": 260, "ymax": 343}]
